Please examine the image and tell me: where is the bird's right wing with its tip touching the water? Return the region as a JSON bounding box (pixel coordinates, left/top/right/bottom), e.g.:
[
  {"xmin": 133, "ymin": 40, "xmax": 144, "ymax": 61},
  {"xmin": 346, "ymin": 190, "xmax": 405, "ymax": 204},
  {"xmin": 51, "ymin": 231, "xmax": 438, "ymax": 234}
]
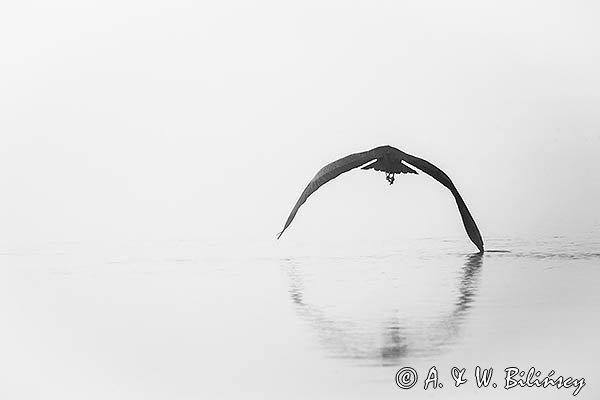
[{"xmin": 398, "ymin": 150, "xmax": 483, "ymax": 252}]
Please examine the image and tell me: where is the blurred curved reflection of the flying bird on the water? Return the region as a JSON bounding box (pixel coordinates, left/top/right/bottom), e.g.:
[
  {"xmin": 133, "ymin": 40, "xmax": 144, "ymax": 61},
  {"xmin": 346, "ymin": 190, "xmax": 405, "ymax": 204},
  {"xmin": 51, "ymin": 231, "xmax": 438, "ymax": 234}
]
[{"xmin": 282, "ymin": 253, "xmax": 483, "ymax": 365}]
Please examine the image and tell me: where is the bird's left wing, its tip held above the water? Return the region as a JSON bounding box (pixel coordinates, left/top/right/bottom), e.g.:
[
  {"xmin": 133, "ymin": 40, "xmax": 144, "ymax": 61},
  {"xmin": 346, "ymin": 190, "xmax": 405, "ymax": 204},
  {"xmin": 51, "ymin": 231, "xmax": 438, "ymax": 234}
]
[{"xmin": 277, "ymin": 149, "xmax": 379, "ymax": 239}]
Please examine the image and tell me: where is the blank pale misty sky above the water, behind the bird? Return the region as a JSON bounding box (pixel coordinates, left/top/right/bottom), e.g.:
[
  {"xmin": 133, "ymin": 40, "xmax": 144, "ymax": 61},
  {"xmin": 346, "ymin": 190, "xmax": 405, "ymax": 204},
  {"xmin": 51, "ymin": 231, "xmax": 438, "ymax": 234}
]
[{"xmin": 0, "ymin": 0, "xmax": 600, "ymax": 246}]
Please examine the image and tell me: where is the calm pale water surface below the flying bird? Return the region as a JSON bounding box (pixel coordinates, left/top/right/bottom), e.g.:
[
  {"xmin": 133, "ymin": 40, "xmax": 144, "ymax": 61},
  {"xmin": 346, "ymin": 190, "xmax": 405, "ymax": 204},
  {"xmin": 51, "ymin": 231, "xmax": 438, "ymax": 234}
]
[{"xmin": 0, "ymin": 237, "xmax": 600, "ymax": 399}]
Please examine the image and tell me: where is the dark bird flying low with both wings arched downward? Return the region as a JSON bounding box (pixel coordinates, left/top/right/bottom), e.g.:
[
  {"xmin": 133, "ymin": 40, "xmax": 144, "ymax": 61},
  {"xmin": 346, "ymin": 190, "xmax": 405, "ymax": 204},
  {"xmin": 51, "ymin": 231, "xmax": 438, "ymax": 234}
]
[{"xmin": 277, "ymin": 146, "xmax": 483, "ymax": 252}]
